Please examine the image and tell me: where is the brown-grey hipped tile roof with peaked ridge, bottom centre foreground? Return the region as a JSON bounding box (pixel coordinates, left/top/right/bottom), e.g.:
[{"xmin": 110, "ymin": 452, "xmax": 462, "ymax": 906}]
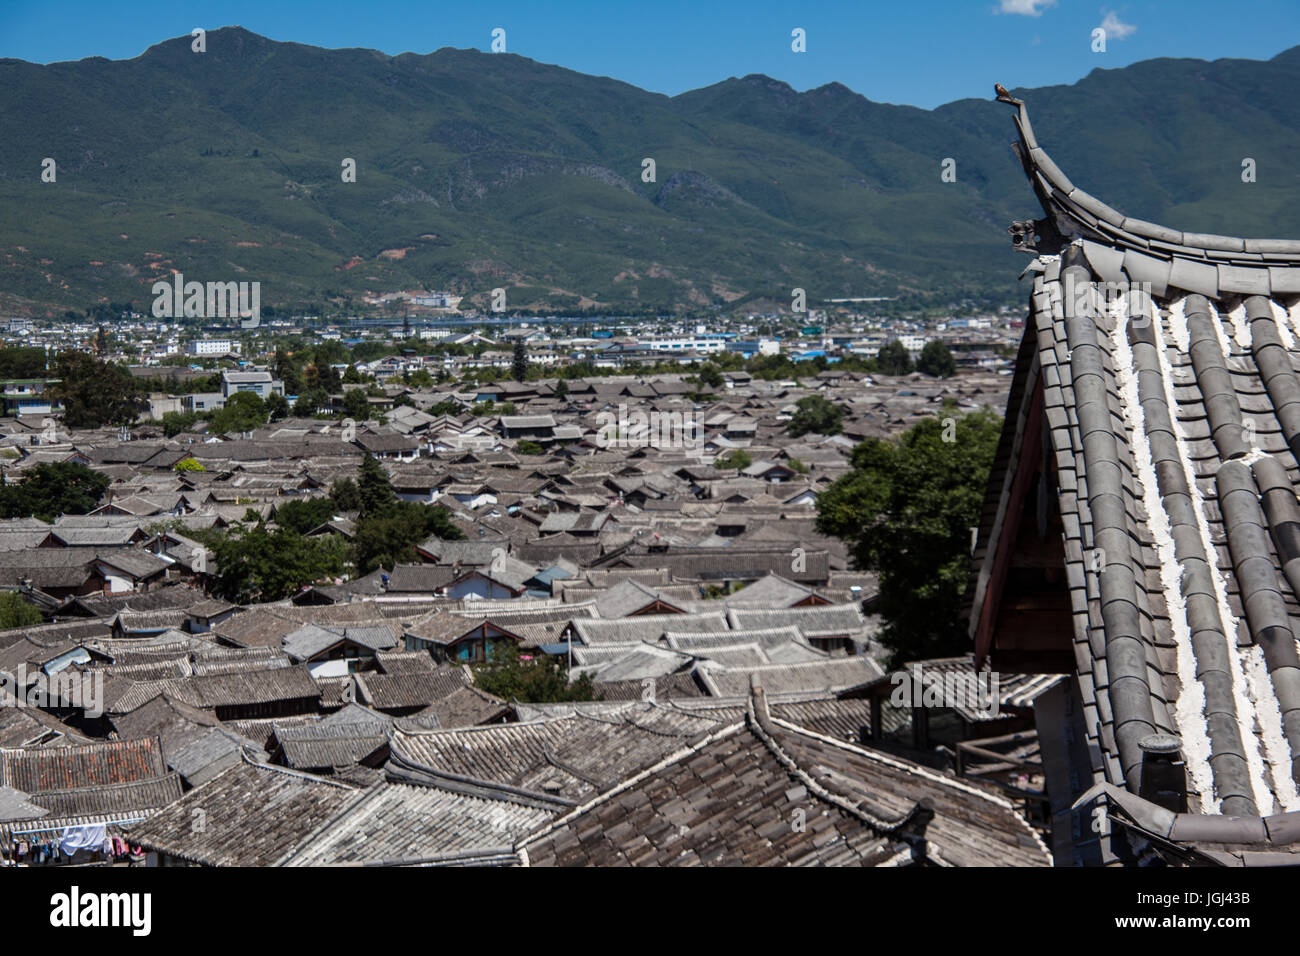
[{"xmin": 519, "ymin": 695, "xmax": 1049, "ymax": 866}]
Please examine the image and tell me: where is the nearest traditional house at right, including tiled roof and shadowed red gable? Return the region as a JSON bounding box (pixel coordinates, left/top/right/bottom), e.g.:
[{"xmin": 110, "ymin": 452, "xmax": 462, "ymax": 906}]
[{"xmin": 970, "ymin": 90, "xmax": 1300, "ymax": 865}]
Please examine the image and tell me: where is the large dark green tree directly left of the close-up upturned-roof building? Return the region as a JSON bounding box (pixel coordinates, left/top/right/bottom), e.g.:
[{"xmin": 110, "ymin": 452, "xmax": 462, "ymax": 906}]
[{"xmin": 816, "ymin": 411, "xmax": 1001, "ymax": 665}]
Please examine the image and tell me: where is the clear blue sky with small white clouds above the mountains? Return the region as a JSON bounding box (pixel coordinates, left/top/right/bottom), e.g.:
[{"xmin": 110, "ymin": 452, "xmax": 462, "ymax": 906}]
[{"xmin": 0, "ymin": 0, "xmax": 1300, "ymax": 108}]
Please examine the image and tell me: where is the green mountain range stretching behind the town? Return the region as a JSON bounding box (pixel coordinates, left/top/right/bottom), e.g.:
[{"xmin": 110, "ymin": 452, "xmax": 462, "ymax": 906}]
[{"xmin": 0, "ymin": 27, "xmax": 1300, "ymax": 315}]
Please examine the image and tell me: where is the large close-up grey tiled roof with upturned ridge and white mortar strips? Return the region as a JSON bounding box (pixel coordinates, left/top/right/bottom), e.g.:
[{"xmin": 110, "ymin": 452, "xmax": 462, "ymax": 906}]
[{"xmin": 971, "ymin": 95, "xmax": 1300, "ymax": 863}]
